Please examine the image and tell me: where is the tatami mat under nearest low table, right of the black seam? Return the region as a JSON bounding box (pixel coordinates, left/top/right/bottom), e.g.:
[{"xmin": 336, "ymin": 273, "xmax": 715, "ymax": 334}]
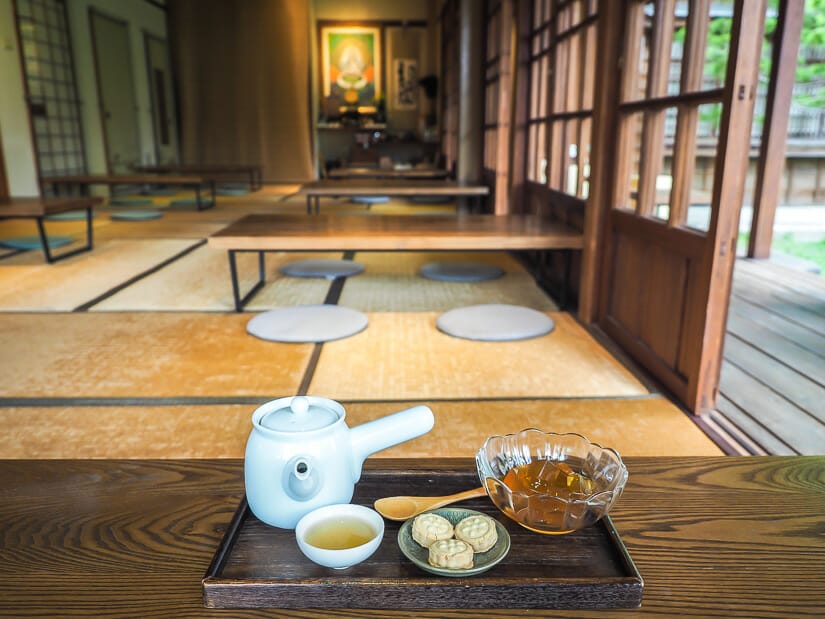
[{"xmin": 339, "ymin": 252, "xmax": 558, "ymax": 312}]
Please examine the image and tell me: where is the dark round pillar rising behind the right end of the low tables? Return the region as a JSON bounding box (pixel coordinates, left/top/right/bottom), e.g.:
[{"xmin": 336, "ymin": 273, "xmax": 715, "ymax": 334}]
[{"xmin": 456, "ymin": 0, "xmax": 484, "ymax": 208}]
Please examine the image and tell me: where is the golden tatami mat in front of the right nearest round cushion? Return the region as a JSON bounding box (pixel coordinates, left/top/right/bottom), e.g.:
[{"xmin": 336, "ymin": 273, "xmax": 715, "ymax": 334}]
[{"xmin": 310, "ymin": 312, "xmax": 647, "ymax": 400}]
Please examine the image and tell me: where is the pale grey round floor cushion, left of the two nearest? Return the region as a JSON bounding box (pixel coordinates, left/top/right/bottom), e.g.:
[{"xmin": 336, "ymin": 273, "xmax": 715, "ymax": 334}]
[{"xmin": 246, "ymin": 304, "xmax": 368, "ymax": 343}]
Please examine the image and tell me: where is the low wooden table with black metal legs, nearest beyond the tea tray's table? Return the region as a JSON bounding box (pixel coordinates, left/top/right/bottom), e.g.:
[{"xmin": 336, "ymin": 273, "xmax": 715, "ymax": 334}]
[{"xmin": 209, "ymin": 214, "xmax": 584, "ymax": 312}]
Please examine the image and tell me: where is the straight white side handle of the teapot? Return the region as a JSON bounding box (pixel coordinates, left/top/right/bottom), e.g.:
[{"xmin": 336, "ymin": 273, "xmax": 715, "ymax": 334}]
[{"xmin": 350, "ymin": 405, "xmax": 435, "ymax": 482}]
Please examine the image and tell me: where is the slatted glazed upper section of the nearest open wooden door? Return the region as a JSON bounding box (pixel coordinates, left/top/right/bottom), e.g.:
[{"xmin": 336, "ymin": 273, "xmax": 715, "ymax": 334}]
[{"xmin": 613, "ymin": 0, "xmax": 724, "ymax": 230}]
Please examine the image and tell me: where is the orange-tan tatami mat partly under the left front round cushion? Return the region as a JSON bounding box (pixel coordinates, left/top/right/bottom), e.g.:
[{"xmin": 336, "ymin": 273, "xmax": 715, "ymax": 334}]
[{"xmin": 0, "ymin": 312, "xmax": 313, "ymax": 398}]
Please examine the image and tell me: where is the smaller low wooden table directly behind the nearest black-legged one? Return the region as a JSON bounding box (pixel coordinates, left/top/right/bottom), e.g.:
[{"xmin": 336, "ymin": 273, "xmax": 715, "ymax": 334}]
[{"xmin": 298, "ymin": 178, "xmax": 490, "ymax": 214}]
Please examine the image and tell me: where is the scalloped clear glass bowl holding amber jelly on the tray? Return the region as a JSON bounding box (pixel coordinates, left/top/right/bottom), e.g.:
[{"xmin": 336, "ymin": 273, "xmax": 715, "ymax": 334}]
[{"xmin": 476, "ymin": 428, "xmax": 627, "ymax": 534}]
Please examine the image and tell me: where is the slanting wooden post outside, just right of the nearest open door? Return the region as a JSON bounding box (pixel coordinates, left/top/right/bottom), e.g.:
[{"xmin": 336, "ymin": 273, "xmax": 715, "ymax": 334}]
[{"xmin": 748, "ymin": 0, "xmax": 805, "ymax": 258}]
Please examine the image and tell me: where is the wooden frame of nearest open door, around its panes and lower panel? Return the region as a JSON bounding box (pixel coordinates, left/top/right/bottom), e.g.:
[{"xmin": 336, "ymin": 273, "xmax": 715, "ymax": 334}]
[{"xmin": 580, "ymin": 0, "xmax": 765, "ymax": 413}]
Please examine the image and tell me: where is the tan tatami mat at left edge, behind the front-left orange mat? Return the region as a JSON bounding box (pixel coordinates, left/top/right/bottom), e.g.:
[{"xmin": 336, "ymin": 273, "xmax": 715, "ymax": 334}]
[{"xmin": 0, "ymin": 239, "xmax": 194, "ymax": 311}]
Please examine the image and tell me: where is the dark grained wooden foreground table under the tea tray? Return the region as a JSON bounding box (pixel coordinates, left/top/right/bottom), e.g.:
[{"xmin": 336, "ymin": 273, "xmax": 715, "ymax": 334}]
[{"xmin": 0, "ymin": 456, "xmax": 825, "ymax": 619}]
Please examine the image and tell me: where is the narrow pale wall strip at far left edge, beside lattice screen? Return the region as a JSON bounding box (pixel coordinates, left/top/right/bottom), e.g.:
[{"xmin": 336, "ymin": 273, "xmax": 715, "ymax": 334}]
[{"xmin": 0, "ymin": 0, "xmax": 40, "ymax": 197}]
